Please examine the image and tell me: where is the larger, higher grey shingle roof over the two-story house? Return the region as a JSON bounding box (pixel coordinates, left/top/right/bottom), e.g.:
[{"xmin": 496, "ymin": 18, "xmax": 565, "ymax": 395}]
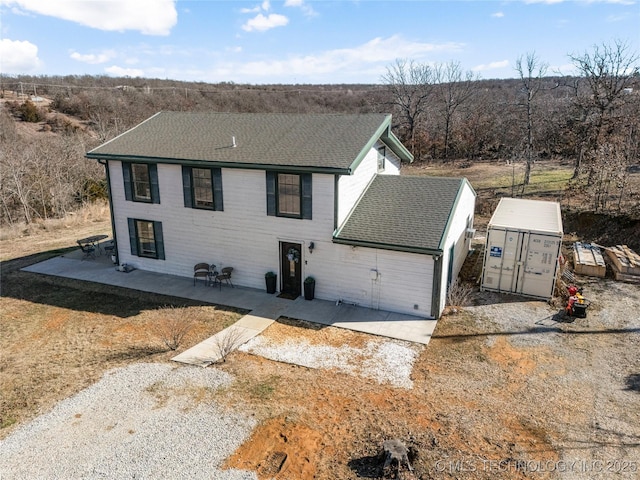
[{"xmin": 87, "ymin": 112, "xmax": 410, "ymax": 170}]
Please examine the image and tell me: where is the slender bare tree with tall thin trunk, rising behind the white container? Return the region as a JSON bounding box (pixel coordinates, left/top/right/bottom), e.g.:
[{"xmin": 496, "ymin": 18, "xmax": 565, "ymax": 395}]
[{"xmin": 516, "ymin": 52, "xmax": 548, "ymax": 188}]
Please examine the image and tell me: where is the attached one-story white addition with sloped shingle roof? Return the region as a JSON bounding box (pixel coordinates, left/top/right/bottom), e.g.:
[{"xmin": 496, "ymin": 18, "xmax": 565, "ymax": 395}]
[{"xmin": 332, "ymin": 175, "xmax": 476, "ymax": 318}]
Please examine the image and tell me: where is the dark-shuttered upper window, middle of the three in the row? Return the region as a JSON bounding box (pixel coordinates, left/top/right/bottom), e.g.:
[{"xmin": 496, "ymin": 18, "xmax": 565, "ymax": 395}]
[{"xmin": 182, "ymin": 166, "xmax": 223, "ymax": 210}]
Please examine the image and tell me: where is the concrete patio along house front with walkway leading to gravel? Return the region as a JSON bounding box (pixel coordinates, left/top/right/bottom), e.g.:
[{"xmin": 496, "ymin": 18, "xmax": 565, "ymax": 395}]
[{"xmin": 23, "ymin": 246, "xmax": 437, "ymax": 366}]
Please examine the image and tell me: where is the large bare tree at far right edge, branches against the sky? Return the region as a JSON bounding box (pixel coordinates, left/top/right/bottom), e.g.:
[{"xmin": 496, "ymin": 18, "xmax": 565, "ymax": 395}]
[{"xmin": 569, "ymin": 40, "xmax": 640, "ymax": 178}]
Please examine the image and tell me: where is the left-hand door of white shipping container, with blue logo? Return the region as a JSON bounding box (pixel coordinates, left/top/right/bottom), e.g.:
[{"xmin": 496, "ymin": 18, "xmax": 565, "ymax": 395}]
[{"xmin": 482, "ymin": 229, "xmax": 524, "ymax": 292}]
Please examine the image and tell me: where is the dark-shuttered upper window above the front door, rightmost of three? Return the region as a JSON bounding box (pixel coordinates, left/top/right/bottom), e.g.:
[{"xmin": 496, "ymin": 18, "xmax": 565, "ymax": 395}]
[{"xmin": 266, "ymin": 171, "xmax": 312, "ymax": 220}]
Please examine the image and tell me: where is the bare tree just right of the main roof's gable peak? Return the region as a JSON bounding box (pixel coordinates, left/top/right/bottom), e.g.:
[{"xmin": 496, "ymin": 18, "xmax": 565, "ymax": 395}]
[{"xmin": 382, "ymin": 59, "xmax": 434, "ymax": 157}]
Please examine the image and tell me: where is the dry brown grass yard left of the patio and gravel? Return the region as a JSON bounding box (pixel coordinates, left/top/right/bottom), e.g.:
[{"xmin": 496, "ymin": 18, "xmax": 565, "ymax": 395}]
[{"xmin": 0, "ymin": 218, "xmax": 246, "ymax": 438}]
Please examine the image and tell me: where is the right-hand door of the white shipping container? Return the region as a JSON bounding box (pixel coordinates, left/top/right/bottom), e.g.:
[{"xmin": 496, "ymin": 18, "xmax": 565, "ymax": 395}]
[{"xmin": 520, "ymin": 233, "xmax": 561, "ymax": 298}]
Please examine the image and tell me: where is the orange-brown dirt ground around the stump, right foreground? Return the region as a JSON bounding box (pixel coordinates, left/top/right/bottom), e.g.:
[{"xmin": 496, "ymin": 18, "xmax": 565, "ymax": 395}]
[{"xmin": 216, "ymin": 280, "xmax": 640, "ymax": 479}]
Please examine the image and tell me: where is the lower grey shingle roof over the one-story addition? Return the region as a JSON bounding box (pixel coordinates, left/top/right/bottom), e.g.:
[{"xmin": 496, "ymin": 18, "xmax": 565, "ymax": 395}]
[{"xmin": 334, "ymin": 175, "xmax": 465, "ymax": 252}]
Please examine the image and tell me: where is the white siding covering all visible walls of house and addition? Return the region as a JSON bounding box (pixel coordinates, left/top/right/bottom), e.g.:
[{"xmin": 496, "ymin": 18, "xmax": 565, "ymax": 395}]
[{"xmin": 109, "ymin": 144, "xmax": 452, "ymax": 317}]
